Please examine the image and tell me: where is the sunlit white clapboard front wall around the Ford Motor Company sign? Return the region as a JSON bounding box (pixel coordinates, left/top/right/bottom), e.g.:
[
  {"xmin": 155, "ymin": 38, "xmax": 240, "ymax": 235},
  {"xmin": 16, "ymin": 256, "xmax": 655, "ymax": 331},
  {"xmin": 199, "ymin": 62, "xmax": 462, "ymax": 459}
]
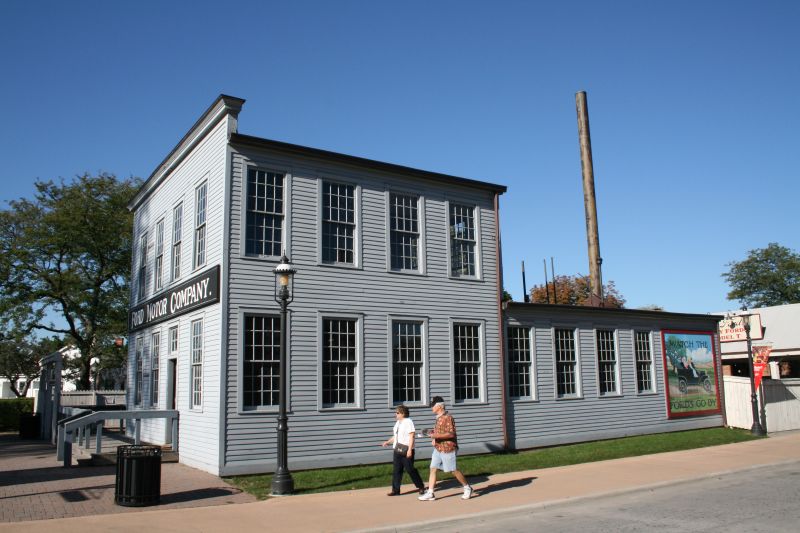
[{"xmin": 128, "ymin": 115, "xmax": 232, "ymax": 473}]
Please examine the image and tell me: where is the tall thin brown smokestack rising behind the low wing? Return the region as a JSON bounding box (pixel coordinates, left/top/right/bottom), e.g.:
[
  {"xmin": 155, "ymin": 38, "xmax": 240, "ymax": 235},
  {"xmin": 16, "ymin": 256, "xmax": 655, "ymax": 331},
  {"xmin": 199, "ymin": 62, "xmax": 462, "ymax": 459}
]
[{"xmin": 575, "ymin": 91, "xmax": 603, "ymax": 306}]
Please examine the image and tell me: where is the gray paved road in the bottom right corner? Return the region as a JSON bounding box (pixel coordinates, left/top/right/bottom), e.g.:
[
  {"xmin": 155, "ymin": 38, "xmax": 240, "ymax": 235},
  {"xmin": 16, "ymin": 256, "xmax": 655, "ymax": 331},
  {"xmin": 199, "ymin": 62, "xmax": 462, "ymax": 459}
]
[{"xmin": 416, "ymin": 461, "xmax": 800, "ymax": 533}]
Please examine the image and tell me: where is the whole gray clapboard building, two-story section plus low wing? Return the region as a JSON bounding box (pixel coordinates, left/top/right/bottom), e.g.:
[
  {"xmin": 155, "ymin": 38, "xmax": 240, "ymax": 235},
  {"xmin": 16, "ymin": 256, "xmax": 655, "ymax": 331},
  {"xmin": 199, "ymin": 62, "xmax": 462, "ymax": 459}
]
[{"xmin": 127, "ymin": 95, "xmax": 722, "ymax": 475}]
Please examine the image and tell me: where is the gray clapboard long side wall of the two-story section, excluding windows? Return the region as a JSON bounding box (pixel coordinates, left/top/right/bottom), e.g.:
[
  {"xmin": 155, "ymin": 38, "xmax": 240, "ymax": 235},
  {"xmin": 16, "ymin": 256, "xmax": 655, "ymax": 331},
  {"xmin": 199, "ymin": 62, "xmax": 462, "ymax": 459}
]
[{"xmin": 223, "ymin": 146, "xmax": 503, "ymax": 473}]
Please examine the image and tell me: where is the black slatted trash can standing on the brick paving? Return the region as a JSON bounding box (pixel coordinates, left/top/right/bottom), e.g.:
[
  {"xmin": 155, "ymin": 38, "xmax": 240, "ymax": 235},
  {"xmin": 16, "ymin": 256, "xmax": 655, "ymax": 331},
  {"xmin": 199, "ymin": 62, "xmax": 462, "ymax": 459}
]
[{"xmin": 114, "ymin": 446, "xmax": 161, "ymax": 507}]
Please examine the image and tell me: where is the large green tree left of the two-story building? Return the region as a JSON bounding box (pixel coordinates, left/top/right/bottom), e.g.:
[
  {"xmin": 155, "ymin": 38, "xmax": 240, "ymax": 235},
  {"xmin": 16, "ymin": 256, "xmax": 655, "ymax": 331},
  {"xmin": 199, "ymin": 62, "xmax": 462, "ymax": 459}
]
[{"xmin": 0, "ymin": 174, "xmax": 140, "ymax": 389}]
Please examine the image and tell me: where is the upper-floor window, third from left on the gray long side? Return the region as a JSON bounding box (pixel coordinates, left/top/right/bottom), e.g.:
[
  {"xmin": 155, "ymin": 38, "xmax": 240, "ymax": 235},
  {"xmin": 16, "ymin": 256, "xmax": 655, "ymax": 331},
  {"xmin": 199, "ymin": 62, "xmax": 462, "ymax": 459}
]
[{"xmin": 389, "ymin": 193, "xmax": 419, "ymax": 270}]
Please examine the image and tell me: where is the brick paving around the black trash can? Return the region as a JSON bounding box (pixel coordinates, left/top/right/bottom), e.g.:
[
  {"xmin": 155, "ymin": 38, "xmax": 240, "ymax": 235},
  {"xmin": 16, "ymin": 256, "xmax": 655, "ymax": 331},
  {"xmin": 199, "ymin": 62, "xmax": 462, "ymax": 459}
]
[{"xmin": 0, "ymin": 434, "xmax": 256, "ymax": 522}]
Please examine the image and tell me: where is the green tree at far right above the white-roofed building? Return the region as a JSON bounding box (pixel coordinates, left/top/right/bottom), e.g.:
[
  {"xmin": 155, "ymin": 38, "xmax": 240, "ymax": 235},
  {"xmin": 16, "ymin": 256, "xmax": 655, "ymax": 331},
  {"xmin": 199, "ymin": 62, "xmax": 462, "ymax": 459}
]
[{"xmin": 722, "ymin": 242, "xmax": 800, "ymax": 307}]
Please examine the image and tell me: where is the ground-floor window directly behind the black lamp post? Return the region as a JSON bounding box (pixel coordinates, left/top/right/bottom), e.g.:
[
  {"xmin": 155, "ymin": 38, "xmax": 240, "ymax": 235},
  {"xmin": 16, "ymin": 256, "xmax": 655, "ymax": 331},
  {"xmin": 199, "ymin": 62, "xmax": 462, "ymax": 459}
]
[{"xmin": 242, "ymin": 315, "xmax": 281, "ymax": 409}]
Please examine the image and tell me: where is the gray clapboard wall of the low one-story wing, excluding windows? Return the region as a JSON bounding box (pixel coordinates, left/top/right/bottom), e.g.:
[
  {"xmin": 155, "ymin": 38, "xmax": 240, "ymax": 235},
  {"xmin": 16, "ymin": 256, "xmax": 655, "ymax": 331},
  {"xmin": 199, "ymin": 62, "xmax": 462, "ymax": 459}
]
[{"xmin": 505, "ymin": 305, "xmax": 723, "ymax": 448}]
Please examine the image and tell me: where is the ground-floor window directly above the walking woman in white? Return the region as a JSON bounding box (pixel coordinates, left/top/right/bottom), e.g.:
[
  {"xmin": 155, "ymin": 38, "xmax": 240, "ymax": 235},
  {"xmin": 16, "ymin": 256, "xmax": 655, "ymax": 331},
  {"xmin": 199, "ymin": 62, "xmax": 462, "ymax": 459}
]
[{"xmin": 392, "ymin": 321, "xmax": 425, "ymax": 404}]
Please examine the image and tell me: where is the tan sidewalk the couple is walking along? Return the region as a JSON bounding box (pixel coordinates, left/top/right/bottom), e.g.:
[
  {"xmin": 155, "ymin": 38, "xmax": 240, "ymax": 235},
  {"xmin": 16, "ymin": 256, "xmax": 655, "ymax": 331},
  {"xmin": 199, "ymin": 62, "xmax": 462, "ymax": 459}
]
[{"xmin": 0, "ymin": 432, "xmax": 800, "ymax": 533}]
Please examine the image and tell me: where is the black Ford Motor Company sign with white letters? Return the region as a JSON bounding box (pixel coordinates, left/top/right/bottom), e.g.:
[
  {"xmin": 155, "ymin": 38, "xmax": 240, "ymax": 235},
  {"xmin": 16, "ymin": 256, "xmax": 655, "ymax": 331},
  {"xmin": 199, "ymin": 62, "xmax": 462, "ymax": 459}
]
[{"xmin": 128, "ymin": 265, "xmax": 219, "ymax": 331}]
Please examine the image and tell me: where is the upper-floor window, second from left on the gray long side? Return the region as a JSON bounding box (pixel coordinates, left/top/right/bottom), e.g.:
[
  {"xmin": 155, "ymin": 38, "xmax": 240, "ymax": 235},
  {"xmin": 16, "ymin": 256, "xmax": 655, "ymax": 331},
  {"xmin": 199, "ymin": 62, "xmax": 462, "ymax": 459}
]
[{"xmin": 322, "ymin": 181, "xmax": 356, "ymax": 265}]
